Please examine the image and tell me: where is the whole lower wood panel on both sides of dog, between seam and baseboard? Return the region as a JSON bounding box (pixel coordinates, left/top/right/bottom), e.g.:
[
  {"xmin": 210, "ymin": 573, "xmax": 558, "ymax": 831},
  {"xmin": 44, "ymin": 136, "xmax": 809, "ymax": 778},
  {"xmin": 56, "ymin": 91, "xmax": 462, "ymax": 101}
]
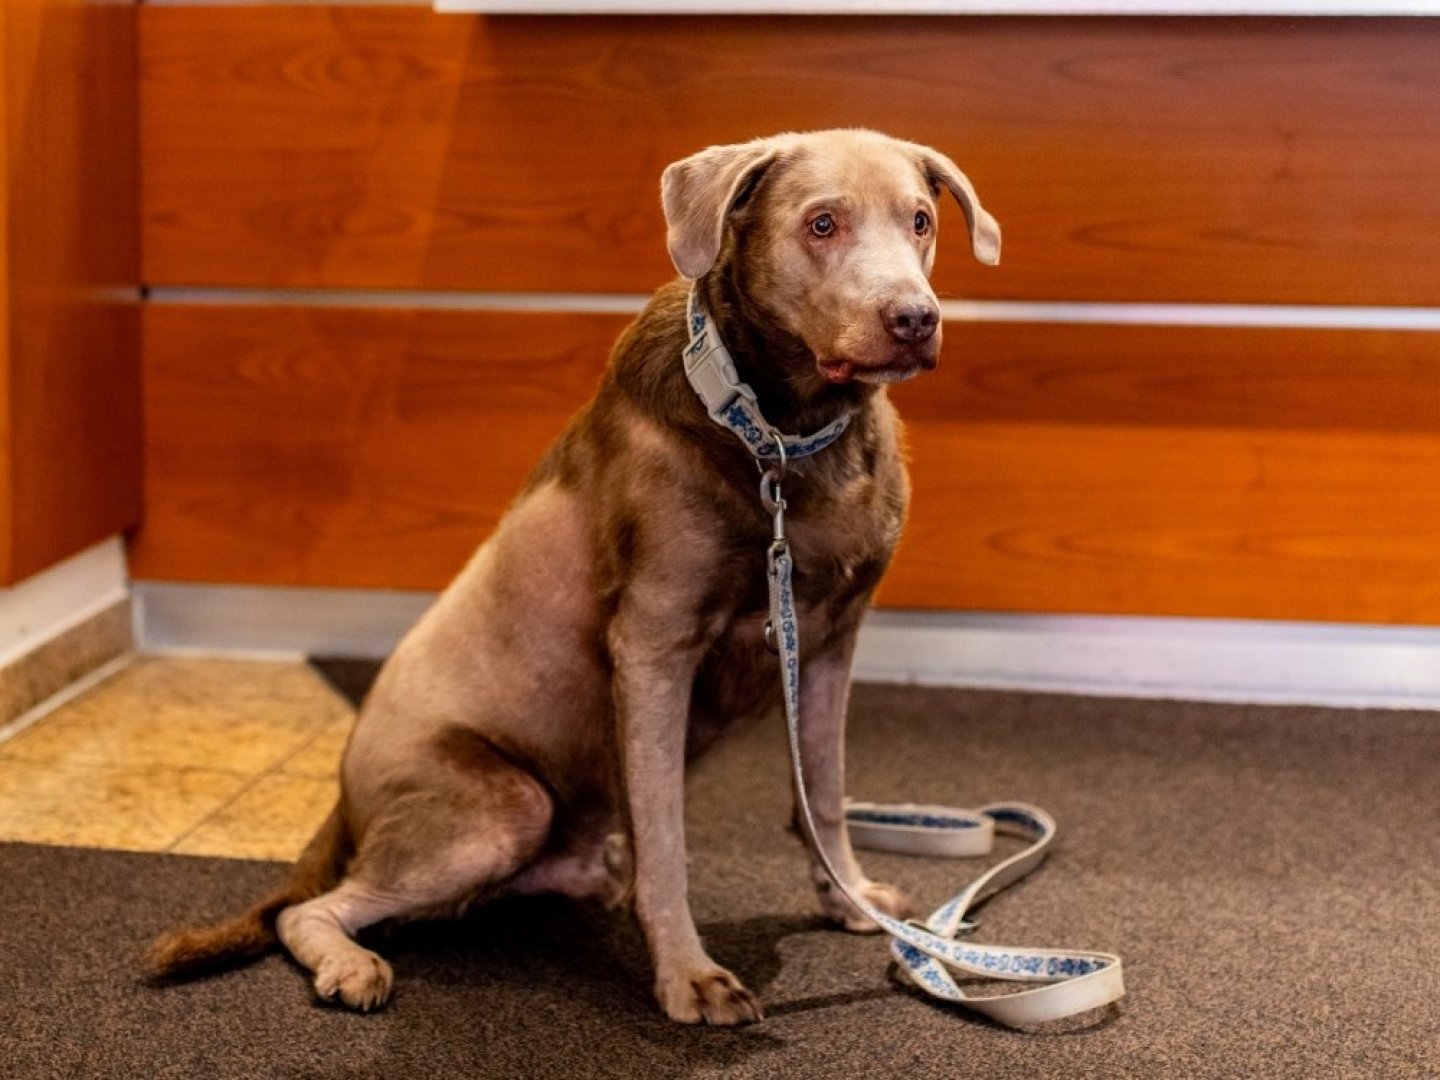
[{"xmin": 132, "ymin": 304, "xmax": 1440, "ymax": 622}]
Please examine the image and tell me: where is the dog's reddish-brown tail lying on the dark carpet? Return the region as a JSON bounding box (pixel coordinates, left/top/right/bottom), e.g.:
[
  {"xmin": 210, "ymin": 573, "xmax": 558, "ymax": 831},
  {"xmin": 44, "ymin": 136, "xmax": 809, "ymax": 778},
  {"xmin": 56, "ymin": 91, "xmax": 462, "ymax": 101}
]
[{"xmin": 145, "ymin": 805, "xmax": 351, "ymax": 981}]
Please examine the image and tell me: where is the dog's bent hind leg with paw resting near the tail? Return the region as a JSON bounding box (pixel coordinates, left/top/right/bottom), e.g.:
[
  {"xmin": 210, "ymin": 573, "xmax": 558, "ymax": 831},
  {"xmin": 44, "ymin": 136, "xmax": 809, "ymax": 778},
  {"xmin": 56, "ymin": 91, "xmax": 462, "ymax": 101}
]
[{"xmin": 275, "ymin": 752, "xmax": 554, "ymax": 1011}]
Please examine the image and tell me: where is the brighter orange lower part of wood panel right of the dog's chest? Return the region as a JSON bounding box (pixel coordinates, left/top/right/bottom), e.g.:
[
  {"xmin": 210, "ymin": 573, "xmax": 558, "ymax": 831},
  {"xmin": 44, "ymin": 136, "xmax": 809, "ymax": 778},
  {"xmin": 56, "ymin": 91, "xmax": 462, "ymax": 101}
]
[{"xmin": 881, "ymin": 422, "xmax": 1440, "ymax": 624}]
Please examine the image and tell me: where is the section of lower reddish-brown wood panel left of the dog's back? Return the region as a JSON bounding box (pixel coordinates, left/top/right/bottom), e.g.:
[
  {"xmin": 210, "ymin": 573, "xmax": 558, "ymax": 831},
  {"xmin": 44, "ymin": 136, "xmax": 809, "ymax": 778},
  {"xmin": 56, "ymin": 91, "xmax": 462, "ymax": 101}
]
[{"xmin": 131, "ymin": 304, "xmax": 626, "ymax": 589}]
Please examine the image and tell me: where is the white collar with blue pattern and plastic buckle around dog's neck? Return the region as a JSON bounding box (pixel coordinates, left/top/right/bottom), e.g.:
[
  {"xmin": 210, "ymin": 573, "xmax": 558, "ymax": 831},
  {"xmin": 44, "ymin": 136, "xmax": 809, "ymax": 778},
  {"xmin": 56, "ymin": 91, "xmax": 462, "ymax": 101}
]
[{"xmin": 681, "ymin": 288, "xmax": 851, "ymax": 461}]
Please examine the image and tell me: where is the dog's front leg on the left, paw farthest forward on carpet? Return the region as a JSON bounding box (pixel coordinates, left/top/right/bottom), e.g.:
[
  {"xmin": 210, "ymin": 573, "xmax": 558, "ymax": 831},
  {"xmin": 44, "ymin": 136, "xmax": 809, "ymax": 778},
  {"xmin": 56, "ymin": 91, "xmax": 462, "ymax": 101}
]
[{"xmin": 611, "ymin": 611, "xmax": 760, "ymax": 1024}]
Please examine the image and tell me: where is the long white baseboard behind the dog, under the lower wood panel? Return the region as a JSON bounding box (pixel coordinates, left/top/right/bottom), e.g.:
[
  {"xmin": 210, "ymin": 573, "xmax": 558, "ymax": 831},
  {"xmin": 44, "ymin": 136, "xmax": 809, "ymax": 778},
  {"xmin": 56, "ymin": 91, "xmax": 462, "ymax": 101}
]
[{"xmin": 135, "ymin": 582, "xmax": 1440, "ymax": 708}]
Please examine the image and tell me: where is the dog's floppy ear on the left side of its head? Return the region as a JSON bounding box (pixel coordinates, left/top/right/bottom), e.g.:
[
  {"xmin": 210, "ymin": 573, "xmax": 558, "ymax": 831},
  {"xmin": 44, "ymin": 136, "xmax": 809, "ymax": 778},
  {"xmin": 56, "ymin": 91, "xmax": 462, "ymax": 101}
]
[{"xmin": 660, "ymin": 140, "xmax": 779, "ymax": 278}]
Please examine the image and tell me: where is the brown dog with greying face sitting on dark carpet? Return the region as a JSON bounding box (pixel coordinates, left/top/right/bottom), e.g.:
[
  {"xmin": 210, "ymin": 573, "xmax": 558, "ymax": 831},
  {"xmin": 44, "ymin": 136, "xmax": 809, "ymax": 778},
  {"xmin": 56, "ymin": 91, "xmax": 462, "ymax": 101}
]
[{"xmin": 148, "ymin": 130, "xmax": 999, "ymax": 1025}]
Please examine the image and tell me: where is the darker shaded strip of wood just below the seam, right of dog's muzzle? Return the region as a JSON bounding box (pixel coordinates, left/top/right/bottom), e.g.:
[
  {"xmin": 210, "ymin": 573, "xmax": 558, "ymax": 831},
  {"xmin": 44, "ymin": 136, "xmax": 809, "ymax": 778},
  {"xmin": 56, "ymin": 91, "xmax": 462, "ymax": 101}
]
[{"xmin": 893, "ymin": 323, "xmax": 1440, "ymax": 438}]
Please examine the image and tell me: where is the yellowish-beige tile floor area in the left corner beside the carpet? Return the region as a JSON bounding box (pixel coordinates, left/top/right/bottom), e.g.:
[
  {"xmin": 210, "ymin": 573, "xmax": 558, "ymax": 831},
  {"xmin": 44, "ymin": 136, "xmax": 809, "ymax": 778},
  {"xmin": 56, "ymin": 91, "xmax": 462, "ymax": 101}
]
[{"xmin": 0, "ymin": 657, "xmax": 354, "ymax": 860}]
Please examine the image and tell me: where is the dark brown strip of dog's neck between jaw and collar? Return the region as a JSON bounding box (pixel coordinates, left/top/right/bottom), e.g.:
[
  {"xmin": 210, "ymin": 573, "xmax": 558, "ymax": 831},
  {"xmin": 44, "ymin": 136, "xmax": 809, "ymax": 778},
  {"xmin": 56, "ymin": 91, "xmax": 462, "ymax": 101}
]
[{"xmin": 694, "ymin": 266, "xmax": 876, "ymax": 433}]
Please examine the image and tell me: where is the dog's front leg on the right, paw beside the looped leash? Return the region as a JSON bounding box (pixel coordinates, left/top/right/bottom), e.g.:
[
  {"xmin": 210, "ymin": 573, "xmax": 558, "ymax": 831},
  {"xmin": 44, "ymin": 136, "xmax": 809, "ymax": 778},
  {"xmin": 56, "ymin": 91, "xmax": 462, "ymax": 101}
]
[{"xmin": 795, "ymin": 631, "xmax": 910, "ymax": 933}]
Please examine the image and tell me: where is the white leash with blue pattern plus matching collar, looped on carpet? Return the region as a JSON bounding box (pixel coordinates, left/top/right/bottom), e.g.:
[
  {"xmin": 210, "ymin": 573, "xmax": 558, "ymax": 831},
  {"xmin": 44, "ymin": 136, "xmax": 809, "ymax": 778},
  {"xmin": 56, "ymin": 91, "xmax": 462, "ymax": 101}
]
[{"xmin": 685, "ymin": 291, "xmax": 1125, "ymax": 1027}]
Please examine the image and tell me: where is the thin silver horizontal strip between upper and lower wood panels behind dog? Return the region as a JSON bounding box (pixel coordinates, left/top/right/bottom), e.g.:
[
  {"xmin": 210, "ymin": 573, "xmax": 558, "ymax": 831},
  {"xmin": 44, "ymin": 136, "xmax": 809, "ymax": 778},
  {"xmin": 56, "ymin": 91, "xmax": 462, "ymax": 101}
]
[{"xmin": 145, "ymin": 285, "xmax": 1440, "ymax": 331}]
